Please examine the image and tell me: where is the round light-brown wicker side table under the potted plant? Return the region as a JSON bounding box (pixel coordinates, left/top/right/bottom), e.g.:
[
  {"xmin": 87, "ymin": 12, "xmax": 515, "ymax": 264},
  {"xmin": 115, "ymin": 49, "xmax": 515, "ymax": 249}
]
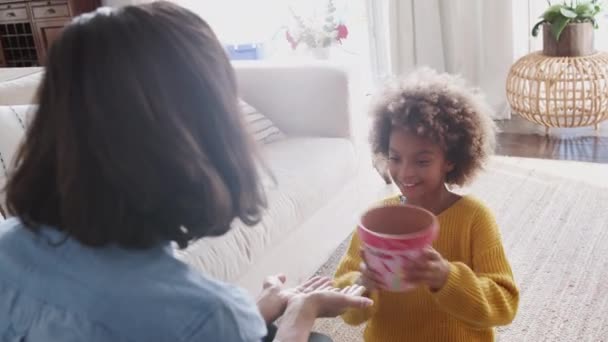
[{"xmin": 507, "ymin": 52, "xmax": 608, "ymax": 131}]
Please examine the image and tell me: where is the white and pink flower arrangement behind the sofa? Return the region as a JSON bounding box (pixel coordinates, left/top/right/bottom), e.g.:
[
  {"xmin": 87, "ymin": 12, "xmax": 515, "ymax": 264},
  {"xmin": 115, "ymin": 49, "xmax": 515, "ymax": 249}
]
[{"xmin": 285, "ymin": 0, "xmax": 348, "ymax": 50}]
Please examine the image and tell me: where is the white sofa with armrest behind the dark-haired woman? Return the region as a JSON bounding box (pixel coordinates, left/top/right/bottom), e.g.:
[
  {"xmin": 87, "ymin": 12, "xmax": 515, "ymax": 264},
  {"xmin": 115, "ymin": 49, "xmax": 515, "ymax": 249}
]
[{"xmin": 0, "ymin": 62, "xmax": 368, "ymax": 293}]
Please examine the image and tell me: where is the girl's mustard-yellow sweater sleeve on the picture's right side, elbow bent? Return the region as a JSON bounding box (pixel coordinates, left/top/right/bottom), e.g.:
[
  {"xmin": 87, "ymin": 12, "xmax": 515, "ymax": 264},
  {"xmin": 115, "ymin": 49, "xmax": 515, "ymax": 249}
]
[{"xmin": 433, "ymin": 207, "xmax": 519, "ymax": 328}]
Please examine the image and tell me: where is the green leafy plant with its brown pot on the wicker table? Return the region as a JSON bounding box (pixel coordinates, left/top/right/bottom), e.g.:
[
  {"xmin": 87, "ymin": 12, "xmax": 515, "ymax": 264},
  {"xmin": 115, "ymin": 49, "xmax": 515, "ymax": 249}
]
[{"xmin": 532, "ymin": 0, "xmax": 602, "ymax": 57}]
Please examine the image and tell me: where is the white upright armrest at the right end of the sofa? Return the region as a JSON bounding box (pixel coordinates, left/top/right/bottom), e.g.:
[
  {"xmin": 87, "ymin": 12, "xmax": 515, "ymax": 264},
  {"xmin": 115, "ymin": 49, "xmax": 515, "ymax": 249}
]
[{"xmin": 233, "ymin": 61, "xmax": 351, "ymax": 137}]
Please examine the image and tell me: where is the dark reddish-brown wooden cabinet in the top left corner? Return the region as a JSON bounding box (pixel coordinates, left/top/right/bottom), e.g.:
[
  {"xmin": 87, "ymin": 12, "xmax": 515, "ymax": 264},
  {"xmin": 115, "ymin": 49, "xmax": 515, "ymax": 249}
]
[{"xmin": 0, "ymin": 0, "xmax": 101, "ymax": 67}]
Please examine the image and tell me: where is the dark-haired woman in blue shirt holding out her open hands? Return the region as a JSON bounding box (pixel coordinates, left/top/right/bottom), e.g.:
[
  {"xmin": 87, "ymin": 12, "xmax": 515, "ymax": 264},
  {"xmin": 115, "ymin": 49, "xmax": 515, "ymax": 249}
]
[{"xmin": 0, "ymin": 2, "xmax": 370, "ymax": 342}]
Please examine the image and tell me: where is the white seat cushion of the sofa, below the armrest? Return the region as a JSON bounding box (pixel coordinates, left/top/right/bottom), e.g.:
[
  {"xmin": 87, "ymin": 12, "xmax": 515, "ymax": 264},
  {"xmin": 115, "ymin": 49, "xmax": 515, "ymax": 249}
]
[{"xmin": 177, "ymin": 138, "xmax": 357, "ymax": 281}]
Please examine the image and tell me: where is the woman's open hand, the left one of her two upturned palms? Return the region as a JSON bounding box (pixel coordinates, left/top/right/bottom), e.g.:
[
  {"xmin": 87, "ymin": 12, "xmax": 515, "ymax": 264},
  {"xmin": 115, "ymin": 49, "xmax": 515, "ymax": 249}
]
[{"xmin": 257, "ymin": 274, "xmax": 331, "ymax": 324}]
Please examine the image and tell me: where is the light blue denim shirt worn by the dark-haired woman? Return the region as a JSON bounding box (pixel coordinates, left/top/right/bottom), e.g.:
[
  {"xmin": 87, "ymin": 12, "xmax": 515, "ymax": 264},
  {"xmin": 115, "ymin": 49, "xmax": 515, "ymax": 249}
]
[{"xmin": 0, "ymin": 218, "xmax": 266, "ymax": 342}]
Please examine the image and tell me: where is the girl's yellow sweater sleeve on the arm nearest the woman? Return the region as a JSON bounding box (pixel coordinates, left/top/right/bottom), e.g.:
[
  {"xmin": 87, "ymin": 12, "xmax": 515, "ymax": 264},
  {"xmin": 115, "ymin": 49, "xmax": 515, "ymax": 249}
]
[{"xmin": 334, "ymin": 231, "xmax": 378, "ymax": 325}]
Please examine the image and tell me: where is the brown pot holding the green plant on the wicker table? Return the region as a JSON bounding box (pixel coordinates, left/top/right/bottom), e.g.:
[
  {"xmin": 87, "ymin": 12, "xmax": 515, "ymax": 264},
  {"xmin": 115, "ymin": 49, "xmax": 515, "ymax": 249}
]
[{"xmin": 543, "ymin": 22, "xmax": 595, "ymax": 57}]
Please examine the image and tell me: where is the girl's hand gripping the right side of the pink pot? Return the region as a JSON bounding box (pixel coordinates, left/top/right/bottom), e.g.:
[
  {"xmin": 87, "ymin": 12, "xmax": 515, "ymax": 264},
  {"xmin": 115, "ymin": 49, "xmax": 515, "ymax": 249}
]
[{"xmin": 405, "ymin": 247, "xmax": 450, "ymax": 292}]
